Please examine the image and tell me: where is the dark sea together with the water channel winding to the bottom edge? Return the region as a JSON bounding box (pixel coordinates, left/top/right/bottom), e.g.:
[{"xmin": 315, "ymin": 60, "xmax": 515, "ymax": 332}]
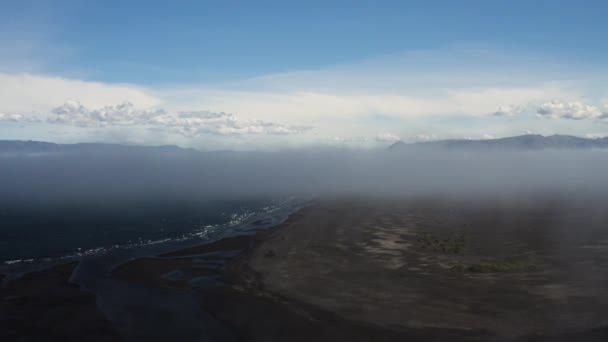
[{"xmin": 0, "ymin": 197, "xmax": 310, "ymax": 341}]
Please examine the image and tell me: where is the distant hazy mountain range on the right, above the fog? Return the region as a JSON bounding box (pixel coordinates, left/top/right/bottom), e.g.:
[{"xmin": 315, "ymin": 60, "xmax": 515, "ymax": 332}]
[{"xmin": 389, "ymin": 134, "xmax": 608, "ymax": 150}]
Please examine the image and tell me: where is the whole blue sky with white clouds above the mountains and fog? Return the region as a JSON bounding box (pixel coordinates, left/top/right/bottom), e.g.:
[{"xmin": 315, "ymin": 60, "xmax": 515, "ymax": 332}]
[{"xmin": 0, "ymin": 0, "xmax": 608, "ymax": 148}]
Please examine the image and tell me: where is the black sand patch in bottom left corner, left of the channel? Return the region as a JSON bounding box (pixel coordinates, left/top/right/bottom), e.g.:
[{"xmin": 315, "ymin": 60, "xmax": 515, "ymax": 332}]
[{"xmin": 0, "ymin": 262, "xmax": 121, "ymax": 341}]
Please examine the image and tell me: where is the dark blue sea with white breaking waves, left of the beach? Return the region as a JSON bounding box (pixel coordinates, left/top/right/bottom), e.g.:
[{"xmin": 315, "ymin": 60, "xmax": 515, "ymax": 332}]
[{"xmin": 0, "ymin": 199, "xmax": 300, "ymax": 265}]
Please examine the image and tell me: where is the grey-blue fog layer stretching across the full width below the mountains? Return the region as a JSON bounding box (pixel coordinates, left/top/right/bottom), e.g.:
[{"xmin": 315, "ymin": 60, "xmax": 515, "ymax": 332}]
[{"xmin": 0, "ymin": 149, "xmax": 608, "ymax": 204}]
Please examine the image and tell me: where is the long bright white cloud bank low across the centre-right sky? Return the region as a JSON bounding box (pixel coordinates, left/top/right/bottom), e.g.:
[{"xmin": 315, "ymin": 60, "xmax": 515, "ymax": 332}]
[{"xmin": 158, "ymin": 83, "xmax": 568, "ymax": 126}]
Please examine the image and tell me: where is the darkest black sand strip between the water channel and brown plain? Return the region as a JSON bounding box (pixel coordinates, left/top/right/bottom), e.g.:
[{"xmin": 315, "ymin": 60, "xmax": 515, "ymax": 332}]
[{"xmin": 196, "ymin": 204, "xmax": 479, "ymax": 342}]
